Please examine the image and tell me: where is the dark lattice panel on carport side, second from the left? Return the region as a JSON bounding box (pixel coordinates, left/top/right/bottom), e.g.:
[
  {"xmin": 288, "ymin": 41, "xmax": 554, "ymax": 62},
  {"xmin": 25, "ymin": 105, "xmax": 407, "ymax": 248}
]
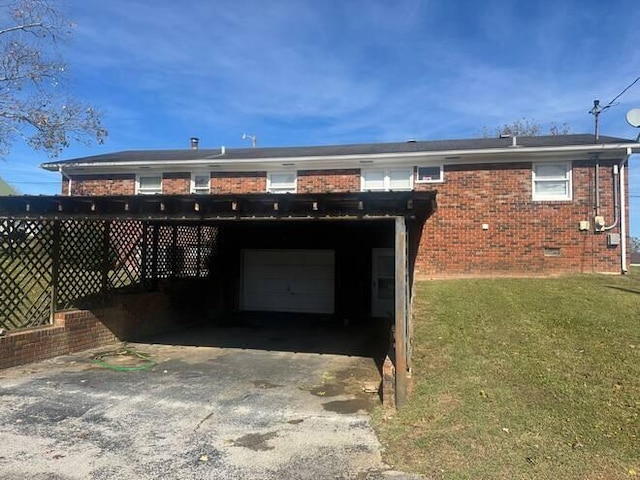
[{"xmin": 56, "ymin": 220, "xmax": 108, "ymax": 309}]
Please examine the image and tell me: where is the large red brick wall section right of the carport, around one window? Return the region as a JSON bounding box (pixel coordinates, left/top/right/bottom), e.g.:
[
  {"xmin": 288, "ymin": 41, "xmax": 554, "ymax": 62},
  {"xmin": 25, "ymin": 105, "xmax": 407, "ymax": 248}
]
[{"xmin": 416, "ymin": 162, "xmax": 620, "ymax": 276}]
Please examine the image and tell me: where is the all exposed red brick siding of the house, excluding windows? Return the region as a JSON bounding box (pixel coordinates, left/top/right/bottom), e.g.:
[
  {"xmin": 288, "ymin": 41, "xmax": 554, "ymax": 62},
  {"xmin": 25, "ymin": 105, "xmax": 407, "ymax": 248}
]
[{"xmin": 63, "ymin": 161, "xmax": 628, "ymax": 278}]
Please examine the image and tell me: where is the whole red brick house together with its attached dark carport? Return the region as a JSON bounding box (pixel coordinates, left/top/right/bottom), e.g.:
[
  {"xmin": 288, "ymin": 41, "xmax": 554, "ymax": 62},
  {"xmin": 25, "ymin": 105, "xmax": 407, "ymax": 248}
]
[{"xmin": 0, "ymin": 135, "xmax": 640, "ymax": 402}]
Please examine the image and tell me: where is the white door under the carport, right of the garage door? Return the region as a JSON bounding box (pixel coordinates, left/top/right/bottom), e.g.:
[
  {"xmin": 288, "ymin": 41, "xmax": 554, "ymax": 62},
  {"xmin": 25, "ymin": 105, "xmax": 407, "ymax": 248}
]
[{"xmin": 371, "ymin": 248, "xmax": 396, "ymax": 317}]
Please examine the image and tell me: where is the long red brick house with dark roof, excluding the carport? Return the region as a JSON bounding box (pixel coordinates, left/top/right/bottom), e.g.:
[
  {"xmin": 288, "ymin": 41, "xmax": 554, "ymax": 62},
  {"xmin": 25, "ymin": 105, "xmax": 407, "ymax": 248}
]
[{"xmin": 43, "ymin": 135, "xmax": 640, "ymax": 277}]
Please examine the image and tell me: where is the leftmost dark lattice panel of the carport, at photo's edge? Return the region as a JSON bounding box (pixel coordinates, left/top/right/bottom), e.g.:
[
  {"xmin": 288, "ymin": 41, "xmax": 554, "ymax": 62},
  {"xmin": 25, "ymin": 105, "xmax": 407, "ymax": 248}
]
[{"xmin": 0, "ymin": 220, "xmax": 53, "ymax": 330}]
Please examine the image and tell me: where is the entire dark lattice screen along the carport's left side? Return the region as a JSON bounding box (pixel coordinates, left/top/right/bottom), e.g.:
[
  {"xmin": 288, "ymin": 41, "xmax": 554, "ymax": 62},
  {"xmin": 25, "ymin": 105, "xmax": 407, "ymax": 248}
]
[{"xmin": 0, "ymin": 220, "xmax": 218, "ymax": 330}]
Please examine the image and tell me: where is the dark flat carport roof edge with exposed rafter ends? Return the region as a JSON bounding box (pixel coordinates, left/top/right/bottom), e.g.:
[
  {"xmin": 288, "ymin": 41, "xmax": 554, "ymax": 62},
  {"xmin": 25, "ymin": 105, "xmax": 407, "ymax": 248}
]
[{"xmin": 0, "ymin": 191, "xmax": 436, "ymax": 220}]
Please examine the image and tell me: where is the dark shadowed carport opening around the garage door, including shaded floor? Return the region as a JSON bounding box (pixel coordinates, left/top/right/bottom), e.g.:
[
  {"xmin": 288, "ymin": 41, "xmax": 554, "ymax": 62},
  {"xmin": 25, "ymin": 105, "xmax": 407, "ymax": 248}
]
[{"xmin": 141, "ymin": 219, "xmax": 395, "ymax": 365}]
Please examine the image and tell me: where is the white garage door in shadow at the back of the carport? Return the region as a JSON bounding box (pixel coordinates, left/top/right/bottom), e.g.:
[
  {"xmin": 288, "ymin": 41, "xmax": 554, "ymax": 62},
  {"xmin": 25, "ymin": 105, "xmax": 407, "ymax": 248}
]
[{"xmin": 241, "ymin": 250, "xmax": 335, "ymax": 313}]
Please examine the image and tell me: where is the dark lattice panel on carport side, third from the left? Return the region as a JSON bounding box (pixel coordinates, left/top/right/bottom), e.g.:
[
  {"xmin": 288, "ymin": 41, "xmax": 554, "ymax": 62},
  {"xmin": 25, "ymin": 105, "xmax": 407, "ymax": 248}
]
[{"xmin": 107, "ymin": 221, "xmax": 144, "ymax": 289}]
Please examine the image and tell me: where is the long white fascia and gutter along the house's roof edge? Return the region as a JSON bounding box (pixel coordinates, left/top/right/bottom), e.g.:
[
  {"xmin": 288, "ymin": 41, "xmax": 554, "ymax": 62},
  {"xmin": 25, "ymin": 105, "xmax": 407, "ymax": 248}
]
[{"xmin": 47, "ymin": 143, "xmax": 640, "ymax": 173}]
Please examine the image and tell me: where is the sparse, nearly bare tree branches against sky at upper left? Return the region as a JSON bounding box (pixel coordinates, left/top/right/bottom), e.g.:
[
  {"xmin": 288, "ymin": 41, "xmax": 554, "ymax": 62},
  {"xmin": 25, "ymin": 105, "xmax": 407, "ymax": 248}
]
[{"xmin": 0, "ymin": 0, "xmax": 107, "ymax": 157}]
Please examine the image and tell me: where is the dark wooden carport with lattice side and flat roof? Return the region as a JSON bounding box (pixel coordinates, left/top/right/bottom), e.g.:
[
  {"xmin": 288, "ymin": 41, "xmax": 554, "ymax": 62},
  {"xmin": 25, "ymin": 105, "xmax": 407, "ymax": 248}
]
[{"xmin": 0, "ymin": 192, "xmax": 436, "ymax": 403}]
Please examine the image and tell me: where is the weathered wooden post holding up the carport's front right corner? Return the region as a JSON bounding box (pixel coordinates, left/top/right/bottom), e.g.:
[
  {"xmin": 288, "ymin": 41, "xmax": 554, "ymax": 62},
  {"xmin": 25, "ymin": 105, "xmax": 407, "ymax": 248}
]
[{"xmin": 394, "ymin": 217, "xmax": 409, "ymax": 407}]
